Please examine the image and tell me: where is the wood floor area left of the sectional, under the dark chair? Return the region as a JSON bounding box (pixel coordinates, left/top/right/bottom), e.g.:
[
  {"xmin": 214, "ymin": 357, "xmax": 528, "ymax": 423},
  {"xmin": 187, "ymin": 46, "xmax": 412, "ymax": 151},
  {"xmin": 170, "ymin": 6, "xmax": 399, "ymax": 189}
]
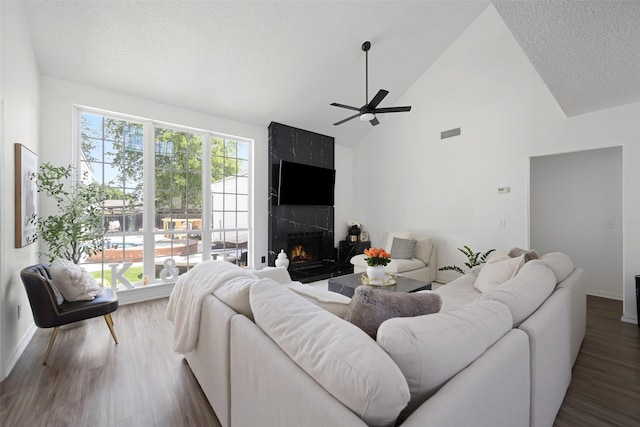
[{"xmin": 0, "ymin": 298, "xmax": 220, "ymax": 427}]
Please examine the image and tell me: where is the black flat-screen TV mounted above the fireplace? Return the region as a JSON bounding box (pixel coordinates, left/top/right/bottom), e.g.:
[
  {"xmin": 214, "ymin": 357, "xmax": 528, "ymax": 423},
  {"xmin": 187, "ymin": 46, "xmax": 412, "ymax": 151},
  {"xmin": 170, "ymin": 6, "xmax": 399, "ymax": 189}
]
[{"xmin": 278, "ymin": 160, "xmax": 336, "ymax": 206}]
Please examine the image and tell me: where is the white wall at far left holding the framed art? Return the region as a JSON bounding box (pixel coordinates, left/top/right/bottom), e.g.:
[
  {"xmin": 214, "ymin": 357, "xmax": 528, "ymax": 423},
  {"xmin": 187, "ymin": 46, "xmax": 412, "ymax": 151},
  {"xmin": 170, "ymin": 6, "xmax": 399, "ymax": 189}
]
[{"xmin": 0, "ymin": 2, "xmax": 40, "ymax": 379}]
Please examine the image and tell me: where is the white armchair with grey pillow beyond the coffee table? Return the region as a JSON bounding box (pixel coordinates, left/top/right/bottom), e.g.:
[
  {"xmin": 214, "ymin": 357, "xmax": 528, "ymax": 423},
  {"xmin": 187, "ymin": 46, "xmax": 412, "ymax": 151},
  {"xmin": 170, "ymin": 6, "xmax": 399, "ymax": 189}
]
[{"xmin": 351, "ymin": 233, "xmax": 438, "ymax": 282}]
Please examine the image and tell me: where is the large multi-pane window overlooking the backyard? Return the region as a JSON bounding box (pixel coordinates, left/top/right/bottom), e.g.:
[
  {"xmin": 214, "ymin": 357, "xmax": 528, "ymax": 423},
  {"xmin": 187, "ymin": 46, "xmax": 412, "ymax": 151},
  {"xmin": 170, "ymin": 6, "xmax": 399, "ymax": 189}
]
[{"xmin": 78, "ymin": 109, "xmax": 250, "ymax": 289}]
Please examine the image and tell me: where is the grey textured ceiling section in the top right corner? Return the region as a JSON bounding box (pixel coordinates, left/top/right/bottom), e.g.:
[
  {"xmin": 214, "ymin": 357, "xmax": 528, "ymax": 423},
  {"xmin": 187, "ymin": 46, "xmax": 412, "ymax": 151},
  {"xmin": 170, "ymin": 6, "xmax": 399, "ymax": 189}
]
[{"xmin": 493, "ymin": 0, "xmax": 640, "ymax": 116}]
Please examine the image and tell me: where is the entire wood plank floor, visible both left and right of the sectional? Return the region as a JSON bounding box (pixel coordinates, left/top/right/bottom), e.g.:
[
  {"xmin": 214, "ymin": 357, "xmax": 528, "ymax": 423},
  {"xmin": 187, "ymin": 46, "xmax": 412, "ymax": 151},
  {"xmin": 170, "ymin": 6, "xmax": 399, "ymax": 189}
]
[{"xmin": 0, "ymin": 297, "xmax": 640, "ymax": 427}]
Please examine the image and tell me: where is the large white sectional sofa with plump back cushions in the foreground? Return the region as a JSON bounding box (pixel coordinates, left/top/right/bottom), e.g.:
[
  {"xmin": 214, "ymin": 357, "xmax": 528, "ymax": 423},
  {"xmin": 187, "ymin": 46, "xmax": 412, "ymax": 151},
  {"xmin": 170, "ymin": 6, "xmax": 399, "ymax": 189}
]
[{"xmin": 174, "ymin": 254, "xmax": 586, "ymax": 427}]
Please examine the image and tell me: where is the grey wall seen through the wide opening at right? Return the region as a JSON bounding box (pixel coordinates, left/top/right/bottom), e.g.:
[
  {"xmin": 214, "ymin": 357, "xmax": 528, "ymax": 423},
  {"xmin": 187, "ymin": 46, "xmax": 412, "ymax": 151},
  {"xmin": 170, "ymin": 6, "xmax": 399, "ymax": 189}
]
[{"xmin": 530, "ymin": 147, "xmax": 624, "ymax": 300}]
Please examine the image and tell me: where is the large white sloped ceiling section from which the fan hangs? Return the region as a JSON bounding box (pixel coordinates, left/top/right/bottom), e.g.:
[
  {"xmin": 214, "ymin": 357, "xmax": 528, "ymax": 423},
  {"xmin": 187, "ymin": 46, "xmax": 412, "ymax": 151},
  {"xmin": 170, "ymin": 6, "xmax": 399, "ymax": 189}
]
[{"xmin": 24, "ymin": 1, "xmax": 489, "ymax": 145}]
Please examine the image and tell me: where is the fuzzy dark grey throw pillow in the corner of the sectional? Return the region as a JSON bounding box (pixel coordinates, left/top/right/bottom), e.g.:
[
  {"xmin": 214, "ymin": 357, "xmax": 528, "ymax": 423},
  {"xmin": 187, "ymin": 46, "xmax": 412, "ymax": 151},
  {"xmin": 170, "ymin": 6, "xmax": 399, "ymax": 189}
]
[{"xmin": 344, "ymin": 286, "xmax": 442, "ymax": 339}]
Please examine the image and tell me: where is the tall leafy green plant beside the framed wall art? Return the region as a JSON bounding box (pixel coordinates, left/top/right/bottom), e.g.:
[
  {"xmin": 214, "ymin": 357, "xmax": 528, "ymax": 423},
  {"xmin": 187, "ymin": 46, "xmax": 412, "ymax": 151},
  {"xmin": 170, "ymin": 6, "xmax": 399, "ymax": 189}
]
[{"xmin": 30, "ymin": 162, "xmax": 106, "ymax": 264}]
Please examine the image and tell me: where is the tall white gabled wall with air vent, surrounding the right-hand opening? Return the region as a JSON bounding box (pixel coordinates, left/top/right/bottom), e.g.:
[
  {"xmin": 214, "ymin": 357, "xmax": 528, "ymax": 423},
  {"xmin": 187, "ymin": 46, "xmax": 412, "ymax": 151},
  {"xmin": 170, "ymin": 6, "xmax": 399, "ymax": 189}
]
[{"xmin": 353, "ymin": 5, "xmax": 640, "ymax": 320}]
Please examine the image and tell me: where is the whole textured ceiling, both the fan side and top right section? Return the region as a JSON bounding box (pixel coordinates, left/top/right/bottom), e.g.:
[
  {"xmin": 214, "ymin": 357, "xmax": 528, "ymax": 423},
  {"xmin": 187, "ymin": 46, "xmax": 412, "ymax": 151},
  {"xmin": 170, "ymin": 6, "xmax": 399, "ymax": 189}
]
[{"xmin": 24, "ymin": 0, "xmax": 640, "ymax": 145}]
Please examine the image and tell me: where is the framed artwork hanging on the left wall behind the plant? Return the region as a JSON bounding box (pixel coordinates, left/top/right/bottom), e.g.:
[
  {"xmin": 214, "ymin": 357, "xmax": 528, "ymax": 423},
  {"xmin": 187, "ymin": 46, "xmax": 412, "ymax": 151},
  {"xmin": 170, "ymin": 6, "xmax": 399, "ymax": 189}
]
[{"xmin": 15, "ymin": 144, "xmax": 38, "ymax": 248}]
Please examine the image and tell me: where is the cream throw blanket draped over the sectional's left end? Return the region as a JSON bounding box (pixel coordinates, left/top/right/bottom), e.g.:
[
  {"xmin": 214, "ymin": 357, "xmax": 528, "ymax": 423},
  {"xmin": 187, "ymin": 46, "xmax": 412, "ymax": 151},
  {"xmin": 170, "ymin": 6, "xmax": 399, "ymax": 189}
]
[{"xmin": 166, "ymin": 261, "xmax": 257, "ymax": 354}]
